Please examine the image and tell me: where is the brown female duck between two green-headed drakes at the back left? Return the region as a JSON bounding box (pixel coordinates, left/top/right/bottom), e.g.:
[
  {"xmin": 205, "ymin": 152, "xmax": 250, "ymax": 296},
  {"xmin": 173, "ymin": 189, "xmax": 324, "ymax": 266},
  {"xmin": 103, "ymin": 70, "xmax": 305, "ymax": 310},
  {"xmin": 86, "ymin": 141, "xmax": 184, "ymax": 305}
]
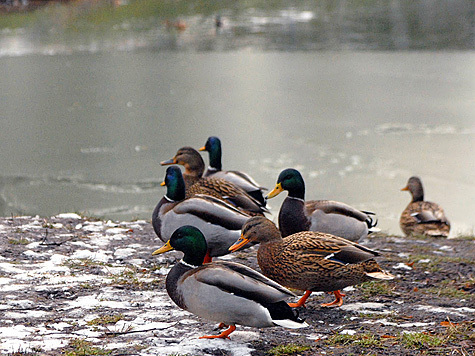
[{"xmin": 160, "ymin": 147, "xmax": 267, "ymax": 215}]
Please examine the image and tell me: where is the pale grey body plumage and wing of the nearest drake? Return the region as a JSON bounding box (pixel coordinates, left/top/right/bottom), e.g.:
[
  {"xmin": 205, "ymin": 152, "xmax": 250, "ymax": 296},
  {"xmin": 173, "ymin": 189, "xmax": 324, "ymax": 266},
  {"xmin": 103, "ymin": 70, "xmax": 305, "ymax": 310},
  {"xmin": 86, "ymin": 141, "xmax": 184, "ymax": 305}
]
[{"xmin": 171, "ymin": 262, "xmax": 306, "ymax": 328}]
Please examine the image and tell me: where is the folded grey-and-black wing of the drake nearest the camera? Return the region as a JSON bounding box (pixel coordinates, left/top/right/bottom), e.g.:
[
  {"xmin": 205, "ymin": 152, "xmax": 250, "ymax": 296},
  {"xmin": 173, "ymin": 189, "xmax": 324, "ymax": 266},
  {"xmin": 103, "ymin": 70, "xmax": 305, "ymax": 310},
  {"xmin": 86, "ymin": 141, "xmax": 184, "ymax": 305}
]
[{"xmin": 194, "ymin": 261, "xmax": 295, "ymax": 303}]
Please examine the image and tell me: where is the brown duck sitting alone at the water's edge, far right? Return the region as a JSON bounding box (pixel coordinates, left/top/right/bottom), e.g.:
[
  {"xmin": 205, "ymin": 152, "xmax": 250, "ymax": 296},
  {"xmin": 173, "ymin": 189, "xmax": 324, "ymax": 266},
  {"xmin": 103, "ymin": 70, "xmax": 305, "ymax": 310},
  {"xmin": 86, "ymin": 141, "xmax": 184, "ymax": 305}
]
[{"xmin": 399, "ymin": 177, "xmax": 450, "ymax": 237}]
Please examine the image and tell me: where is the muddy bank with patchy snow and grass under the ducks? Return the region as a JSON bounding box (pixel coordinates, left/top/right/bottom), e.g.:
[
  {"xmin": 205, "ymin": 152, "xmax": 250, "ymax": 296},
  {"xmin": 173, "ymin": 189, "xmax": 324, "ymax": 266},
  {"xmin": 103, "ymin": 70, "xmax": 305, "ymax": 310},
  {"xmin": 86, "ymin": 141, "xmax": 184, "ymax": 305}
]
[{"xmin": 0, "ymin": 214, "xmax": 475, "ymax": 356}]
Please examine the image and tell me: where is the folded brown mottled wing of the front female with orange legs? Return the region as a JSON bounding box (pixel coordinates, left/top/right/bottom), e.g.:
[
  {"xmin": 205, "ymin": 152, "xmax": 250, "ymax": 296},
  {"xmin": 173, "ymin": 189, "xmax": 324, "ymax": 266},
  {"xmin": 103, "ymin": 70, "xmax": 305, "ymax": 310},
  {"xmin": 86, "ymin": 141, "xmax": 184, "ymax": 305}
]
[{"xmin": 283, "ymin": 231, "xmax": 379, "ymax": 264}]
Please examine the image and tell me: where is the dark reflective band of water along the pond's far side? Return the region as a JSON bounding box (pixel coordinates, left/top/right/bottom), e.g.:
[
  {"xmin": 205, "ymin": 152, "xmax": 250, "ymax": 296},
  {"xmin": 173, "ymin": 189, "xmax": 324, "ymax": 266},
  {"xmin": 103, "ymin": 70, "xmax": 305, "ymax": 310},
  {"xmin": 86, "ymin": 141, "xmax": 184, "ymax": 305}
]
[{"xmin": 0, "ymin": 0, "xmax": 475, "ymax": 56}]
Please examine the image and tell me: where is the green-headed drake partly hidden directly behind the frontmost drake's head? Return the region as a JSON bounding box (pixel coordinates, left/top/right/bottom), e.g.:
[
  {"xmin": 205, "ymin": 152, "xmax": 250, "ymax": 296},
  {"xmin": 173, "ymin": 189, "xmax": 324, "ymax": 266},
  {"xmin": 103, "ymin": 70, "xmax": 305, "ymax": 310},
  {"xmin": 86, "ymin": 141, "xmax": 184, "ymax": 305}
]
[{"xmin": 152, "ymin": 166, "xmax": 250, "ymax": 257}]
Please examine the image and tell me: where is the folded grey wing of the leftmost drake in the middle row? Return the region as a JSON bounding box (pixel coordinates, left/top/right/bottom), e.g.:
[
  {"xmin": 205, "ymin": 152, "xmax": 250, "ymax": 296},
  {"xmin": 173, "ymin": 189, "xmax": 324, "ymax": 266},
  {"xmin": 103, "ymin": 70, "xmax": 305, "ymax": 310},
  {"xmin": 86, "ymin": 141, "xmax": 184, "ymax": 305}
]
[{"xmin": 173, "ymin": 194, "xmax": 250, "ymax": 230}]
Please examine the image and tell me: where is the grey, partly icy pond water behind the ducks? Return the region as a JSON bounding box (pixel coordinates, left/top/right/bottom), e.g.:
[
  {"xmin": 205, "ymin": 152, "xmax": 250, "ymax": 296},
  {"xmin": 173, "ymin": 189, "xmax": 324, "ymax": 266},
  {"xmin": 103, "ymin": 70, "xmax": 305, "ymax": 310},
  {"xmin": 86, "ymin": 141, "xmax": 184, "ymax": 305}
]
[{"xmin": 0, "ymin": 1, "xmax": 475, "ymax": 235}]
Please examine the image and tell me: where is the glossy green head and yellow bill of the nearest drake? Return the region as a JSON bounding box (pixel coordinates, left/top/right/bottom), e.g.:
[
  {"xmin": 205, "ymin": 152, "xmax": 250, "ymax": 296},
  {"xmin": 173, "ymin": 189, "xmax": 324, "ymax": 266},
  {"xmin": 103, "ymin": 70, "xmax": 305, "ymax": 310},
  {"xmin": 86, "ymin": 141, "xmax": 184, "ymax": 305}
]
[{"xmin": 152, "ymin": 225, "xmax": 208, "ymax": 266}]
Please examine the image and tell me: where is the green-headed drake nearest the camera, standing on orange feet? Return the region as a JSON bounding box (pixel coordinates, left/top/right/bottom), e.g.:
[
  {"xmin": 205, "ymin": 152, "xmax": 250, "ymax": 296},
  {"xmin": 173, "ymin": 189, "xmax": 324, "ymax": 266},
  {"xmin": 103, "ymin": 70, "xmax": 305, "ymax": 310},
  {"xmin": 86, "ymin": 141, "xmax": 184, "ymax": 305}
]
[{"xmin": 153, "ymin": 225, "xmax": 307, "ymax": 339}]
